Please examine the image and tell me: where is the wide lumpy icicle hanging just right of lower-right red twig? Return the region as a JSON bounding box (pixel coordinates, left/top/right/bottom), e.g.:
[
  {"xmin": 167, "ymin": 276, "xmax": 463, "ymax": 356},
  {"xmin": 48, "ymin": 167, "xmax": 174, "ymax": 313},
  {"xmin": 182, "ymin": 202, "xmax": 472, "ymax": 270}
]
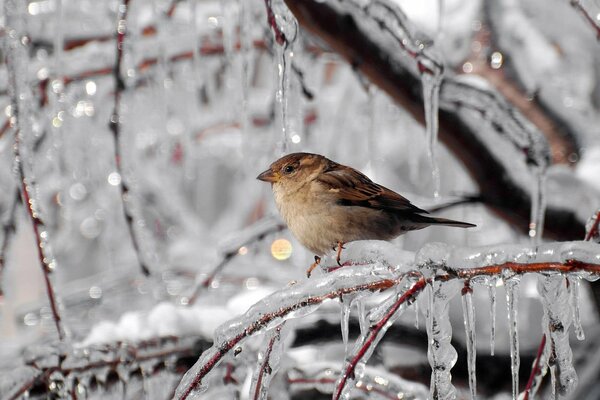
[{"xmin": 538, "ymin": 275, "xmax": 577, "ymax": 396}]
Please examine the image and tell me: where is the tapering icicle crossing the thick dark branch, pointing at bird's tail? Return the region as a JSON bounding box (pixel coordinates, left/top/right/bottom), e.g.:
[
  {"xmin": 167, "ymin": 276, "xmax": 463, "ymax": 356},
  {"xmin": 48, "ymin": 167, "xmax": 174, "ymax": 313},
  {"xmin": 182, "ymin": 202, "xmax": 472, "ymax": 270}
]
[{"xmin": 421, "ymin": 69, "xmax": 442, "ymax": 198}]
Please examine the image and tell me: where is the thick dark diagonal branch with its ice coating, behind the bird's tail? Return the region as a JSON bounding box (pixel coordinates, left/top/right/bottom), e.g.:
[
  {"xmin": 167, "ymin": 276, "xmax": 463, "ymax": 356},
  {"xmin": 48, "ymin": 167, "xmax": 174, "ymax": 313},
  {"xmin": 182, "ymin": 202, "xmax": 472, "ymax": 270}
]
[{"xmin": 286, "ymin": 0, "xmax": 594, "ymax": 240}]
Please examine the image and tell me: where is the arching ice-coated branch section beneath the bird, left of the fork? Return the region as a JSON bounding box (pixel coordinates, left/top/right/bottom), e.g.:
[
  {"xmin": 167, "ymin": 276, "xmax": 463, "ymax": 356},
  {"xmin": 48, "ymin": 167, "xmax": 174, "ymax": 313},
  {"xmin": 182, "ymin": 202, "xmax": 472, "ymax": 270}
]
[{"xmin": 176, "ymin": 266, "xmax": 398, "ymax": 400}]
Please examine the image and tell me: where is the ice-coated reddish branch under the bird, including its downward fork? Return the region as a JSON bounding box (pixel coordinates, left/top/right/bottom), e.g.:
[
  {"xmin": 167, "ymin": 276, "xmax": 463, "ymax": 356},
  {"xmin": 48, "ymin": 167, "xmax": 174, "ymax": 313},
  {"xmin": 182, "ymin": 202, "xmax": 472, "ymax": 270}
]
[{"xmin": 176, "ymin": 242, "xmax": 600, "ymax": 400}]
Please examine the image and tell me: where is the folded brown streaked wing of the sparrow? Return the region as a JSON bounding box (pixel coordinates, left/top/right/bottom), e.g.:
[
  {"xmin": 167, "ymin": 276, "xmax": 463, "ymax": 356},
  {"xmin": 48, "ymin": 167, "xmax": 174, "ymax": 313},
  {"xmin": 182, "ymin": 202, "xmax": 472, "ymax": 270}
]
[{"xmin": 317, "ymin": 162, "xmax": 428, "ymax": 214}]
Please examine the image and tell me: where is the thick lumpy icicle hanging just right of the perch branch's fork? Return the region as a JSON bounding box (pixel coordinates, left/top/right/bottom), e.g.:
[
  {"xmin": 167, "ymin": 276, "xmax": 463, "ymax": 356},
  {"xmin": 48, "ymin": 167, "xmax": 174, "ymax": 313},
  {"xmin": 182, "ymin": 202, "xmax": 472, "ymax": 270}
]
[{"xmin": 427, "ymin": 281, "xmax": 458, "ymax": 400}]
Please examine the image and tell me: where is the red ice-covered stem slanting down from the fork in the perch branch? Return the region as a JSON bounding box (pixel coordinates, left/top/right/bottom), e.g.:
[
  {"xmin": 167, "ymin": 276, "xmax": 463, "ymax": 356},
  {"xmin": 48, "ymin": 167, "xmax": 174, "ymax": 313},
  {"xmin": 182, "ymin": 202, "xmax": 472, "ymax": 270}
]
[{"xmin": 333, "ymin": 277, "xmax": 427, "ymax": 400}]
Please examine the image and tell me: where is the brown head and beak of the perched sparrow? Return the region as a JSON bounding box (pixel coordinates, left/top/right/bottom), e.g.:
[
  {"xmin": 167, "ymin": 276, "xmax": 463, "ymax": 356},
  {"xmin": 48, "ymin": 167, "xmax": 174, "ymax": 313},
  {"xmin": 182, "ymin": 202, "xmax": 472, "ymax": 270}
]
[{"xmin": 256, "ymin": 153, "xmax": 329, "ymax": 192}]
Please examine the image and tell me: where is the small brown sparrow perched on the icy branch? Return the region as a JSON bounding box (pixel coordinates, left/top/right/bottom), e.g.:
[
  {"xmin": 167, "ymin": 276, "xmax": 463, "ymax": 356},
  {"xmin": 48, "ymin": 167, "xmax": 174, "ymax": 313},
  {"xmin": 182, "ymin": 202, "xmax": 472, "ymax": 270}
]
[{"xmin": 256, "ymin": 153, "xmax": 476, "ymax": 277}]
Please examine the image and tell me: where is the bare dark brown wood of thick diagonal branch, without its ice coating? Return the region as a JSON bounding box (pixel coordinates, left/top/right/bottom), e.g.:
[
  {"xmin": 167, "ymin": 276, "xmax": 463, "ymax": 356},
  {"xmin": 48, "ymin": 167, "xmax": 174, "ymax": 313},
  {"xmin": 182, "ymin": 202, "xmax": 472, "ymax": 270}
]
[{"xmin": 286, "ymin": 0, "xmax": 592, "ymax": 240}]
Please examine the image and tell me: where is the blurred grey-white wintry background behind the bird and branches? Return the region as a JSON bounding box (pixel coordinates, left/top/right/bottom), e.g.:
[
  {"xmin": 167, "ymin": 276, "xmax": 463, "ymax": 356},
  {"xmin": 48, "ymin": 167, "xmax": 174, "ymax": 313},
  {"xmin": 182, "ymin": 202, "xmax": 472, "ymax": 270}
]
[{"xmin": 0, "ymin": 0, "xmax": 600, "ymax": 399}]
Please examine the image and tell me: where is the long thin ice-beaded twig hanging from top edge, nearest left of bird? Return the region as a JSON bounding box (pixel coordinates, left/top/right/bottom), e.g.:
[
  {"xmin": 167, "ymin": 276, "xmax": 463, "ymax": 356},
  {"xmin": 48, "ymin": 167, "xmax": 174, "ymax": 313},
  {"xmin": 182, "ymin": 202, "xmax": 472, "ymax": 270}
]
[{"xmin": 110, "ymin": 0, "xmax": 150, "ymax": 276}]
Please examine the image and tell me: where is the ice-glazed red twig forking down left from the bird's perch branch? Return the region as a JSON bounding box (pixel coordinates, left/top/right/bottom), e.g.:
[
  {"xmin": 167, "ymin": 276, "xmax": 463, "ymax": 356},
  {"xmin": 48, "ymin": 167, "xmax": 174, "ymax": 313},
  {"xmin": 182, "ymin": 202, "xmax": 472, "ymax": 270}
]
[{"xmin": 333, "ymin": 278, "xmax": 427, "ymax": 400}]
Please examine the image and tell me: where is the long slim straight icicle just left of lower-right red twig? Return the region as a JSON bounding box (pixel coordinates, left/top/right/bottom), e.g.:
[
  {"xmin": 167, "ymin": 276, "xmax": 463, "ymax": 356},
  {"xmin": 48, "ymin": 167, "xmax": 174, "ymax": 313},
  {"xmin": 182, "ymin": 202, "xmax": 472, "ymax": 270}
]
[{"xmin": 504, "ymin": 277, "xmax": 521, "ymax": 400}]
